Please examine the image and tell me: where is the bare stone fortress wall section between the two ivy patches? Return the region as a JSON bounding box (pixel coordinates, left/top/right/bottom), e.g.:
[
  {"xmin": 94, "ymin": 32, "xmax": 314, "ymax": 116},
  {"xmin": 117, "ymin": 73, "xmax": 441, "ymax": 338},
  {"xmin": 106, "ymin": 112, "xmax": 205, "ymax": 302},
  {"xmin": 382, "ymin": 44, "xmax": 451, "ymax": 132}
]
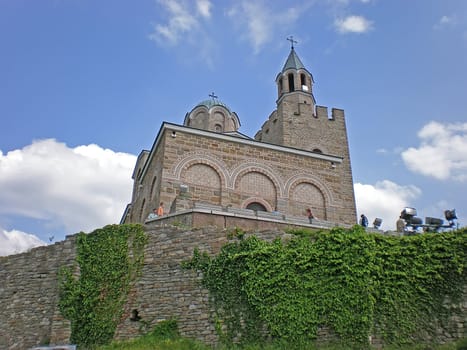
[{"xmin": 116, "ymin": 222, "xmax": 284, "ymax": 344}]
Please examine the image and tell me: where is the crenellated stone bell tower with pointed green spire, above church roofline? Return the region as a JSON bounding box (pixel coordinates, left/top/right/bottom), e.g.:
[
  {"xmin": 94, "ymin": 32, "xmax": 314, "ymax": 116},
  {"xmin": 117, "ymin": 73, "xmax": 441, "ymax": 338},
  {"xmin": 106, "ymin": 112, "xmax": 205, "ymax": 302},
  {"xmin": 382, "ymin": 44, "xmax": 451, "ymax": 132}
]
[{"xmin": 255, "ymin": 37, "xmax": 349, "ymax": 158}]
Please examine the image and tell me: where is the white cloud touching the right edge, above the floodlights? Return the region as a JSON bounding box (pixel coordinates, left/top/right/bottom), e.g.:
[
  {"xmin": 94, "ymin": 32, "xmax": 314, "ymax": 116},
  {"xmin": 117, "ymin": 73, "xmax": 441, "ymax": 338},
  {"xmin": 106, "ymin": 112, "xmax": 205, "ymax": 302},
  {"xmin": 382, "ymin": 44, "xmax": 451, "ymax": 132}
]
[{"xmin": 401, "ymin": 121, "xmax": 467, "ymax": 181}]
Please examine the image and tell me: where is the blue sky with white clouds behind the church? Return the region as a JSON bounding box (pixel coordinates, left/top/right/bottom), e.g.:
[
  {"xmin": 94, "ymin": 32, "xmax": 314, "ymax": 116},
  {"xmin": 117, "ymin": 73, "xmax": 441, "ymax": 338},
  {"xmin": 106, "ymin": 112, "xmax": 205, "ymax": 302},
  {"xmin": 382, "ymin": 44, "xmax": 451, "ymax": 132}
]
[{"xmin": 0, "ymin": 0, "xmax": 467, "ymax": 255}]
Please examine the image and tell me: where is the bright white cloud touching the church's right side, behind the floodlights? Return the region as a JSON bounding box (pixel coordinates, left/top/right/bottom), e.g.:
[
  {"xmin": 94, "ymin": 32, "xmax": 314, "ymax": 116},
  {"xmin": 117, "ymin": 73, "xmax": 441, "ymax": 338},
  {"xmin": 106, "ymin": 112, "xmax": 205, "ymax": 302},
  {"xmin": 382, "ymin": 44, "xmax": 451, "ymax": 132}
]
[{"xmin": 354, "ymin": 180, "xmax": 421, "ymax": 230}]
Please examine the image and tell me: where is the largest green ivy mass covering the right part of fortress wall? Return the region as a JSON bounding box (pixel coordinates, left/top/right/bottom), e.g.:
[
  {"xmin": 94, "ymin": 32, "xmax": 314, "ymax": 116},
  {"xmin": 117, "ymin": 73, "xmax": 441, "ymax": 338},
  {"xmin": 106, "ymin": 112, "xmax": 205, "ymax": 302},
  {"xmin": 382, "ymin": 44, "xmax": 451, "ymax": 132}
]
[{"xmin": 187, "ymin": 226, "xmax": 467, "ymax": 349}]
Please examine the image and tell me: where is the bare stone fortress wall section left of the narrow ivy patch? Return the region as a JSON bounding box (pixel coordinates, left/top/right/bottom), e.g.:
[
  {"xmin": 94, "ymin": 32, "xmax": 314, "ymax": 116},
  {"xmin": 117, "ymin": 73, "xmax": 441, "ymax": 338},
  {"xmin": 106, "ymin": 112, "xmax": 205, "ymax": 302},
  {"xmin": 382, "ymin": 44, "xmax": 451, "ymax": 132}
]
[{"xmin": 0, "ymin": 236, "xmax": 76, "ymax": 350}]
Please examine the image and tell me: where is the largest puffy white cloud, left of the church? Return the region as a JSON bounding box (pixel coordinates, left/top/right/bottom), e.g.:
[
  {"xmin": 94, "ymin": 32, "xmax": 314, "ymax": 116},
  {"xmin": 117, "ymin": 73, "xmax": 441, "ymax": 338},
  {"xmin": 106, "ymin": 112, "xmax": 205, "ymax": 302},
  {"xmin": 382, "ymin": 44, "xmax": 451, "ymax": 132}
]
[{"xmin": 0, "ymin": 139, "xmax": 136, "ymax": 238}]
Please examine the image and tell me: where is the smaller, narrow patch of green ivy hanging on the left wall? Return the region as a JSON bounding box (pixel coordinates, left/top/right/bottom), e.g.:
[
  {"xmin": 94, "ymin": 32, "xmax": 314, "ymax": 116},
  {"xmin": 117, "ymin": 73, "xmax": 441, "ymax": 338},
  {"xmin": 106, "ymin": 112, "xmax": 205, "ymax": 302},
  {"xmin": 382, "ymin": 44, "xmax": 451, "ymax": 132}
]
[{"xmin": 59, "ymin": 225, "xmax": 147, "ymax": 347}]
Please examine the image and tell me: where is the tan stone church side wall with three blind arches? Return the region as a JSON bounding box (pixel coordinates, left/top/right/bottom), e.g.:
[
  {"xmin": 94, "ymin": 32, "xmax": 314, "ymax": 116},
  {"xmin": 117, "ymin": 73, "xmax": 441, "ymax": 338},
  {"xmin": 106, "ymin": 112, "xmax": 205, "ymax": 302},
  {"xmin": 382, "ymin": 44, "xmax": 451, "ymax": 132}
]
[{"xmin": 143, "ymin": 127, "xmax": 356, "ymax": 225}]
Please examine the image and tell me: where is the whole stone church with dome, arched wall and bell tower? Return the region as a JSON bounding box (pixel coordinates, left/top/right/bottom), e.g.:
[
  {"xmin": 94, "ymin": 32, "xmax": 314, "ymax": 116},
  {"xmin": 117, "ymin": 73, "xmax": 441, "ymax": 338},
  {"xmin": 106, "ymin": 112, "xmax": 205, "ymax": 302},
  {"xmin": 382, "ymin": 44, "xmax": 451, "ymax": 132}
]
[{"xmin": 121, "ymin": 46, "xmax": 357, "ymax": 225}]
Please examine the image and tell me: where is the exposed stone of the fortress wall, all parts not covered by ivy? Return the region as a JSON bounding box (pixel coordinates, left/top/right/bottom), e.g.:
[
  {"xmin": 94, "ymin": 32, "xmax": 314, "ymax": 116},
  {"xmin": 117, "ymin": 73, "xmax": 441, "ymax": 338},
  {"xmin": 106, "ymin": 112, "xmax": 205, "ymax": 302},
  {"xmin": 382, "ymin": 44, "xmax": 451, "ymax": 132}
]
[{"xmin": 0, "ymin": 221, "xmax": 467, "ymax": 350}]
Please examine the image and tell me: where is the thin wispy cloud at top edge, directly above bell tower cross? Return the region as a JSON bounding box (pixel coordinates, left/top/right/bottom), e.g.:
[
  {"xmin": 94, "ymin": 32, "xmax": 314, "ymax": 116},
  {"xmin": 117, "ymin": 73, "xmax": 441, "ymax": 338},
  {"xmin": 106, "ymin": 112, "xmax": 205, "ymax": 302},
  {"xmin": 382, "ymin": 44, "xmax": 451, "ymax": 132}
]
[{"xmin": 227, "ymin": 0, "xmax": 311, "ymax": 54}]
